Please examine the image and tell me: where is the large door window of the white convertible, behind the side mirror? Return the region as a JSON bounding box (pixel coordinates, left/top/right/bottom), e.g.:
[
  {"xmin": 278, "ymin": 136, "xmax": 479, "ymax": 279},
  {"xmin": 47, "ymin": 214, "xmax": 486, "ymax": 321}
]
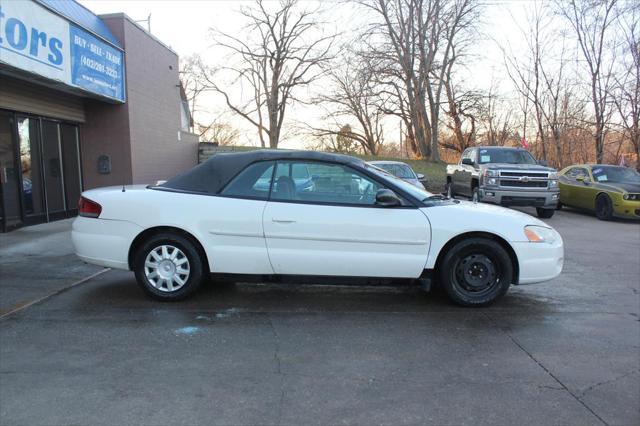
[{"xmin": 271, "ymin": 161, "xmax": 382, "ymax": 205}]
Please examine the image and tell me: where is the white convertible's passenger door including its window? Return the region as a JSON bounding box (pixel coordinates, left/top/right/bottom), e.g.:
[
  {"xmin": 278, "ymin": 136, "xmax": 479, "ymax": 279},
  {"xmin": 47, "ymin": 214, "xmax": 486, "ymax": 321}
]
[{"xmin": 263, "ymin": 161, "xmax": 430, "ymax": 278}]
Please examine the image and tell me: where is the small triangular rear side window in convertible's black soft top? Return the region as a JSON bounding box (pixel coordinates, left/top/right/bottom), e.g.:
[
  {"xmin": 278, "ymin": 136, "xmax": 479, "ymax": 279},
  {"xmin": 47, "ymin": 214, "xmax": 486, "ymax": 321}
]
[{"xmin": 220, "ymin": 161, "xmax": 274, "ymax": 200}]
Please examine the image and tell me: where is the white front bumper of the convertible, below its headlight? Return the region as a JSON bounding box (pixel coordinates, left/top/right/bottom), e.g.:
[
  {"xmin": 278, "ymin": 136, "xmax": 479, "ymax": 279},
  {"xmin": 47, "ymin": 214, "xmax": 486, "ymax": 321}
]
[{"xmin": 512, "ymin": 234, "xmax": 564, "ymax": 284}]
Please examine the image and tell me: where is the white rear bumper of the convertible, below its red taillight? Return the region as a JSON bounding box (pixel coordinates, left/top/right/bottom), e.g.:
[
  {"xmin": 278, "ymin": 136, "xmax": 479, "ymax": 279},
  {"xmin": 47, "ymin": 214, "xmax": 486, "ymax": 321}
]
[{"xmin": 71, "ymin": 216, "xmax": 143, "ymax": 270}]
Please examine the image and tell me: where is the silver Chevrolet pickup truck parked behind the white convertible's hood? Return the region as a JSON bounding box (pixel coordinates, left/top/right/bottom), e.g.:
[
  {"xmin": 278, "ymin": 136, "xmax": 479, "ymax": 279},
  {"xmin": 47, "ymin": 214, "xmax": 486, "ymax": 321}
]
[{"xmin": 446, "ymin": 146, "xmax": 559, "ymax": 218}]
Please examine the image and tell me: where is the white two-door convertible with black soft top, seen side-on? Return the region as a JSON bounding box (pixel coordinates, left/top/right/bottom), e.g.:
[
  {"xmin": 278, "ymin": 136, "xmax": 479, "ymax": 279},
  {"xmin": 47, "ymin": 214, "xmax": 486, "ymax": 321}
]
[{"xmin": 72, "ymin": 150, "xmax": 564, "ymax": 306}]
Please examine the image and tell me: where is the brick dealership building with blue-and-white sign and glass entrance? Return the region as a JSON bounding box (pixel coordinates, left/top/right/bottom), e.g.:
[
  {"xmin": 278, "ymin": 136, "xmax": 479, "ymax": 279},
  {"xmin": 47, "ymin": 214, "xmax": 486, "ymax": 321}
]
[{"xmin": 0, "ymin": 0, "xmax": 198, "ymax": 231}]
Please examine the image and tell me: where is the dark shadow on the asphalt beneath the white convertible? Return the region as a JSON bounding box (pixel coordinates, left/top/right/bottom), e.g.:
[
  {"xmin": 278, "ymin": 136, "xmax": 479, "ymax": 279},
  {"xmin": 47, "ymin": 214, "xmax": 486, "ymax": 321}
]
[{"xmin": 73, "ymin": 271, "xmax": 554, "ymax": 316}]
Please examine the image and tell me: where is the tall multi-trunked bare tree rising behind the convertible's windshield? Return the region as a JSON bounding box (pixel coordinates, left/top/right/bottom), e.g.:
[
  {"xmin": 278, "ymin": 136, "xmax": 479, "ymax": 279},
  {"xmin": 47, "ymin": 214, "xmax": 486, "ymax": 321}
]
[{"xmin": 359, "ymin": 0, "xmax": 478, "ymax": 160}]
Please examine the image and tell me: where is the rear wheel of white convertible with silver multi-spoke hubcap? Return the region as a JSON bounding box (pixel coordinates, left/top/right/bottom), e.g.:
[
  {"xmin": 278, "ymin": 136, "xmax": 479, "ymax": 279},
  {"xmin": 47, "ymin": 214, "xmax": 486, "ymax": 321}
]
[{"xmin": 133, "ymin": 233, "xmax": 208, "ymax": 302}]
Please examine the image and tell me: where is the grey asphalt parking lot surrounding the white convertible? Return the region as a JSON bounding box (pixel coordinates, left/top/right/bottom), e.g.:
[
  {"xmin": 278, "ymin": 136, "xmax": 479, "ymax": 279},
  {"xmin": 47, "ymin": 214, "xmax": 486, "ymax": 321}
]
[{"xmin": 0, "ymin": 210, "xmax": 640, "ymax": 425}]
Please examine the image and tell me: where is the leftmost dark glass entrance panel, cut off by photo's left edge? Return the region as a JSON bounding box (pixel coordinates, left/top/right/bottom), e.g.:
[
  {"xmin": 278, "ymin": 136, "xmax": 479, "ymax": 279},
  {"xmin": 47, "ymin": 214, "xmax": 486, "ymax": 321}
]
[{"xmin": 0, "ymin": 111, "xmax": 22, "ymax": 231}]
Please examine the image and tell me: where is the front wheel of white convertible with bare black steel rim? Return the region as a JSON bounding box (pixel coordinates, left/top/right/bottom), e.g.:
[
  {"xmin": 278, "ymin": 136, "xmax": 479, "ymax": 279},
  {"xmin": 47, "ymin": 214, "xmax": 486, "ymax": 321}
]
[{"xmin": 439, "ymin": 238, "xmax": 513, "ymax": 307}]
